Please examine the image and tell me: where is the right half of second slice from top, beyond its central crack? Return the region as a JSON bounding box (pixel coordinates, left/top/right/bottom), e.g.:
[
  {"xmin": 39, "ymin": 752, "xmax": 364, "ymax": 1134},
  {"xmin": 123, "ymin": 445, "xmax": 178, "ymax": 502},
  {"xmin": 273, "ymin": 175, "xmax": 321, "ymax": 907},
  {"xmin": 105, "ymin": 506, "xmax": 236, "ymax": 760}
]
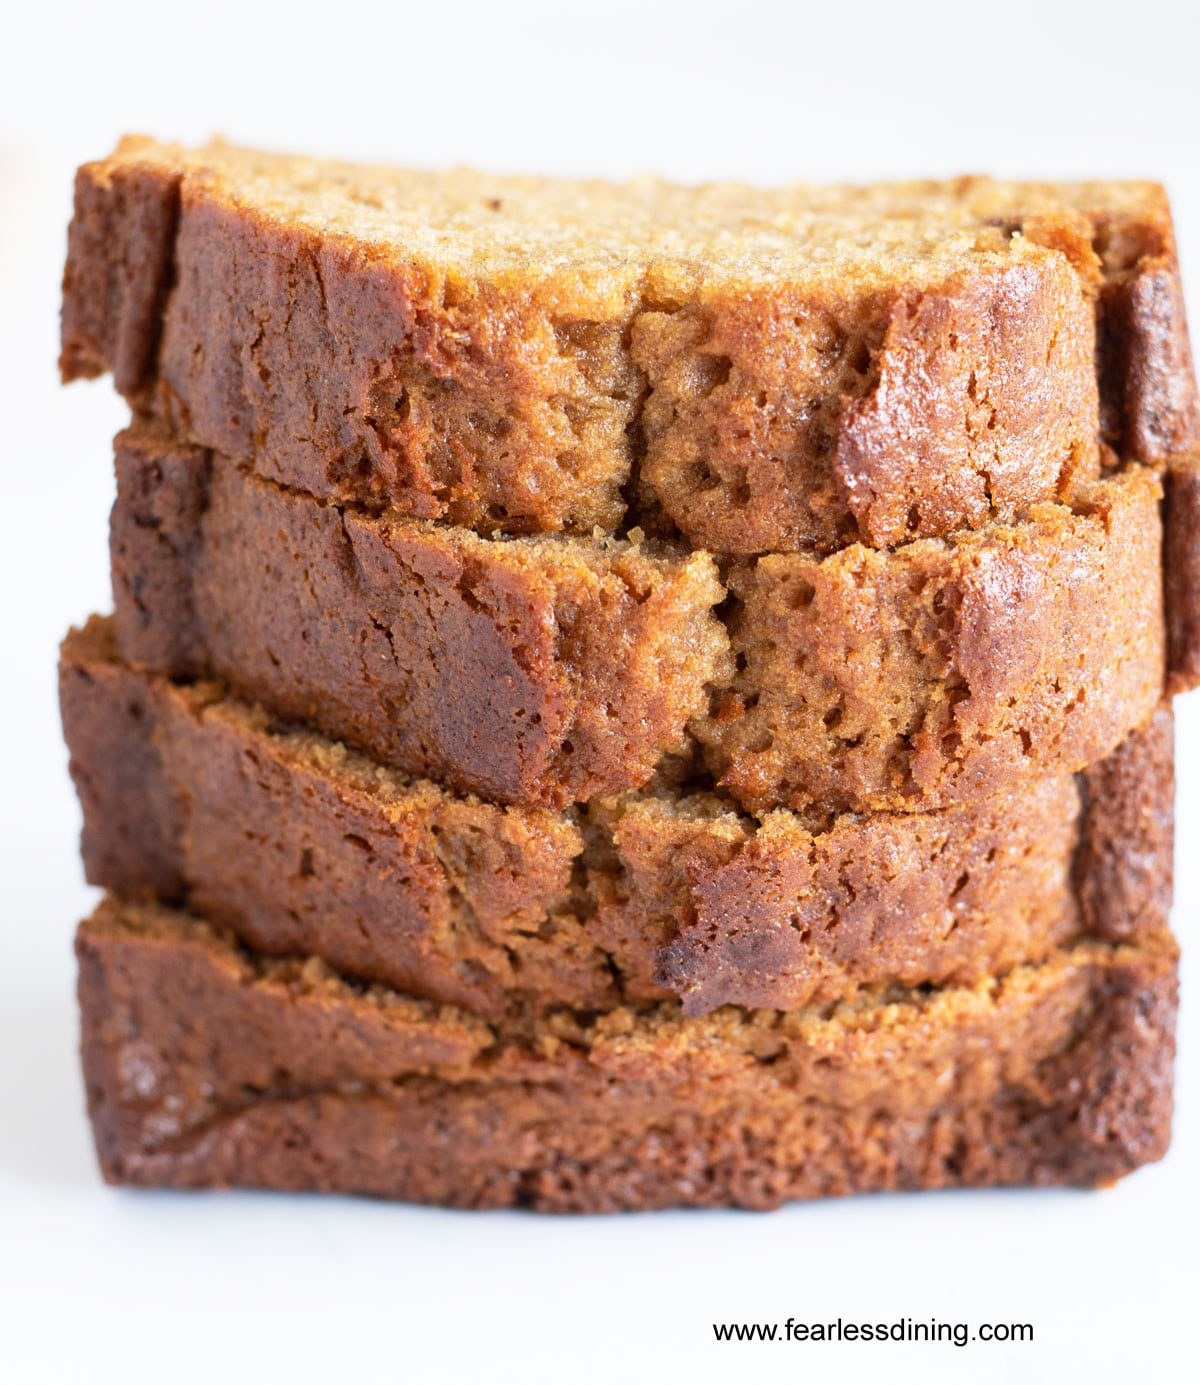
[{"xmin": 691, "ymin": 468, "xmax": 1164, "ymax": 810}]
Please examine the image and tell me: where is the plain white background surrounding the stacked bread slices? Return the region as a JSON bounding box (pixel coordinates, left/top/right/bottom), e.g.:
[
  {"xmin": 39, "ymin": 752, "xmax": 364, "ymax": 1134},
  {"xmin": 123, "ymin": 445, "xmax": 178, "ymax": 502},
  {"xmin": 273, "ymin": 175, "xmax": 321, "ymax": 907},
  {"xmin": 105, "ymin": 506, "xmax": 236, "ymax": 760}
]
[{"xmin": 0, "ymin": 0, "xmax": 1200, "ymax": 1385}]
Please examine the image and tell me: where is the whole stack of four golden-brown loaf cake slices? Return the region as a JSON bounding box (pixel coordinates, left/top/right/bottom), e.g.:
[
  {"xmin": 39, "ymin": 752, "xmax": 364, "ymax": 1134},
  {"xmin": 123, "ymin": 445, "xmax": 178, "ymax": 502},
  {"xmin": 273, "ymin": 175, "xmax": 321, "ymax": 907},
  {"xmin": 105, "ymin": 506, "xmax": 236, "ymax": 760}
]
[{"xmin": 61, "ymin": 139, "xmax": 1200, "ymax": 1210}]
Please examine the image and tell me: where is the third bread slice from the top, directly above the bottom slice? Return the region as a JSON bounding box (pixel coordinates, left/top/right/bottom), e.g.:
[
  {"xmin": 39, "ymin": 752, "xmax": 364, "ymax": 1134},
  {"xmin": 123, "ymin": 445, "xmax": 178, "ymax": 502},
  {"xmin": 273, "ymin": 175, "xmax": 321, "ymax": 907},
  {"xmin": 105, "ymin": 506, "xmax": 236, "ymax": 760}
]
[{"xmin": 60, "ymin": 620, "xmax": 1172, "ymax": 1018}]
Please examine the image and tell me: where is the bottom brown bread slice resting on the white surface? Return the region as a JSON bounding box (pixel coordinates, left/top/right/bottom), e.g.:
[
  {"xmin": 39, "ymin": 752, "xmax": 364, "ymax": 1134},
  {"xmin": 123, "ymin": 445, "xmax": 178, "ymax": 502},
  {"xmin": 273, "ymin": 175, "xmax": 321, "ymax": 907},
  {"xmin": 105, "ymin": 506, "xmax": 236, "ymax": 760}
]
[{"xmin": 76, "ymin": 899, "xmax": 1176, "ymax": 1212}]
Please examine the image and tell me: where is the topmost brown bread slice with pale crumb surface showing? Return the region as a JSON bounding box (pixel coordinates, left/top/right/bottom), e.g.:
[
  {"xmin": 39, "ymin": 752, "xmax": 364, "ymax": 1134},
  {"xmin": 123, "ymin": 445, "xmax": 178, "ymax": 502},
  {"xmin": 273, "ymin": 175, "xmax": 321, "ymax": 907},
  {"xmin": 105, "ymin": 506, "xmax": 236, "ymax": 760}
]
[{"xmin": 62, "ymin": 137, "xmax": 1196, "ymax": 554}]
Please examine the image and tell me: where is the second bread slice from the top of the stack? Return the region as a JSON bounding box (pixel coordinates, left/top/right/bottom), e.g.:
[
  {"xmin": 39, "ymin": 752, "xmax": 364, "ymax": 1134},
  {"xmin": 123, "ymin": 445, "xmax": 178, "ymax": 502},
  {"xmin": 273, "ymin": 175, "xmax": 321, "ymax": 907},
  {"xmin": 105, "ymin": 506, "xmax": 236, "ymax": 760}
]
[{"xmin": 112, "ymin": 424, "xmax": 1165, "ymax": 812}]
